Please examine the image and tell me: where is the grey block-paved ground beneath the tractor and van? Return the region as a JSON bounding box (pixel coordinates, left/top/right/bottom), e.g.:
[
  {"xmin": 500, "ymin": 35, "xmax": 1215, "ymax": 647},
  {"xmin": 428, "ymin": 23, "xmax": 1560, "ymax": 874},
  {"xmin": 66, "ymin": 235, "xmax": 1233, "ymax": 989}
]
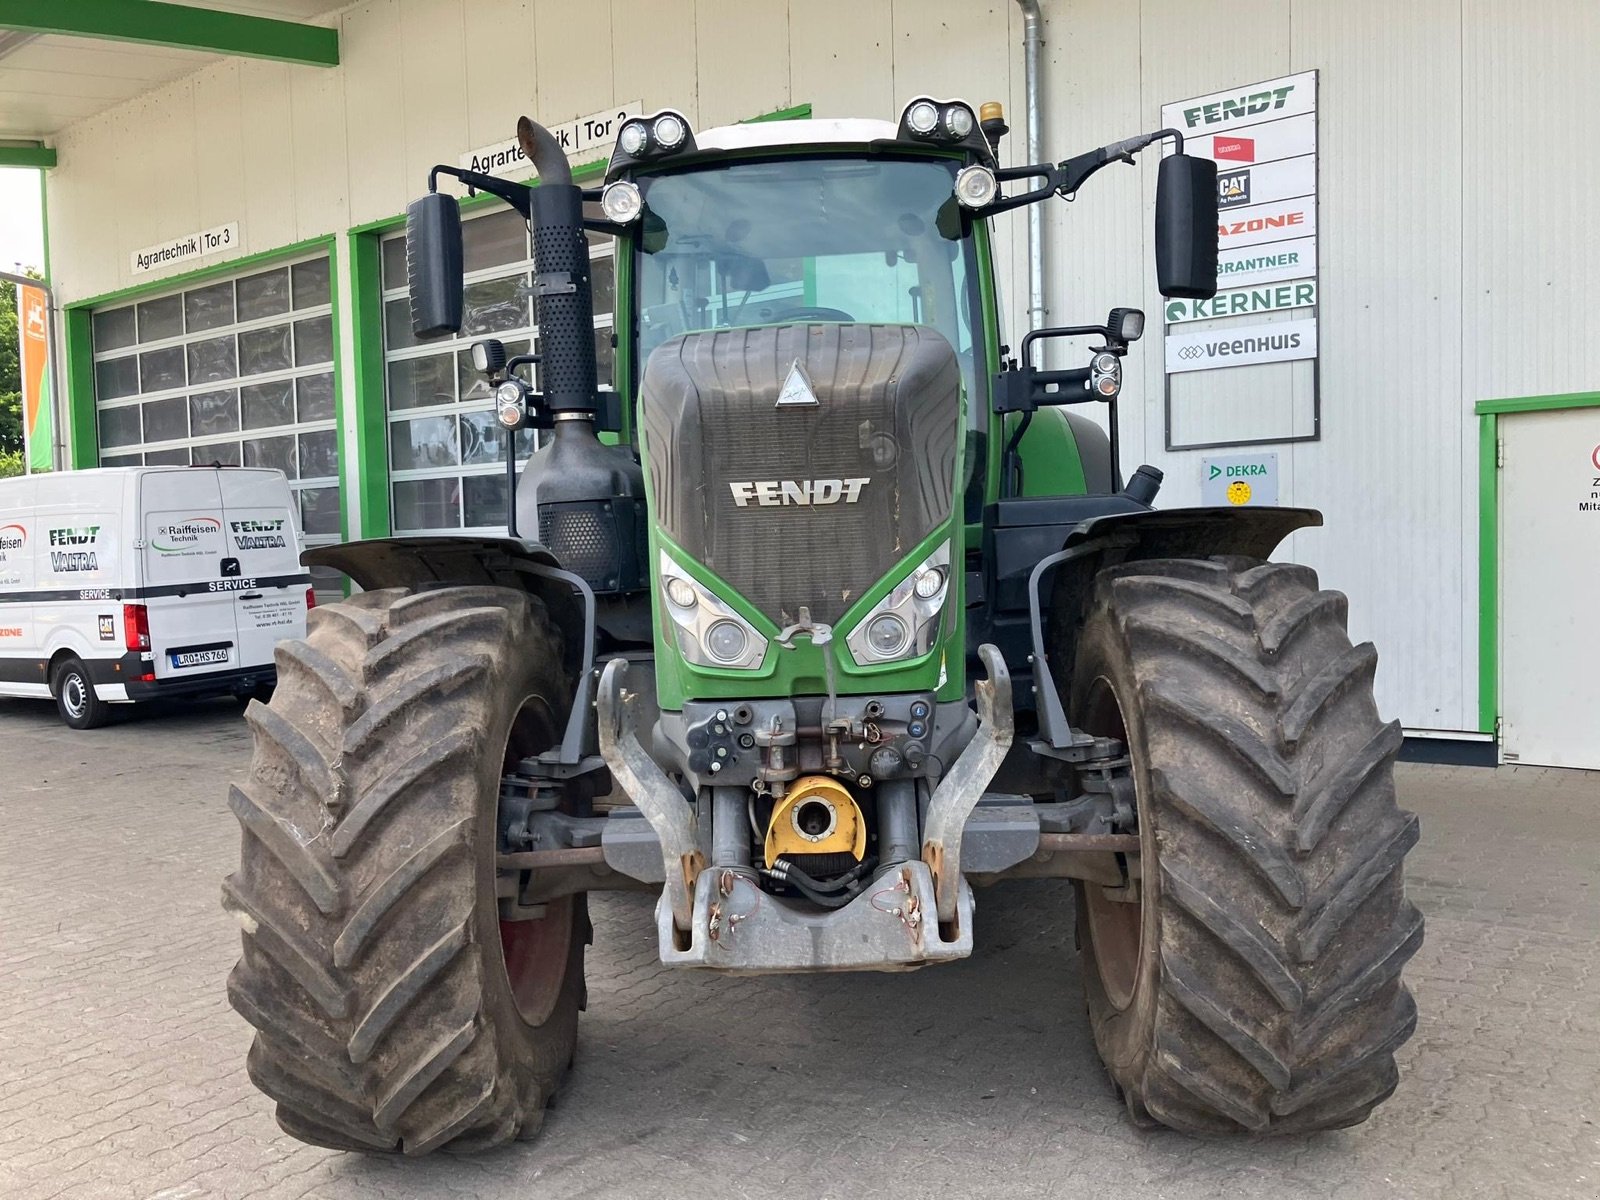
[{"xmin": 0, "ymin": 701, "xmax": 1600, "ymax": 1200}]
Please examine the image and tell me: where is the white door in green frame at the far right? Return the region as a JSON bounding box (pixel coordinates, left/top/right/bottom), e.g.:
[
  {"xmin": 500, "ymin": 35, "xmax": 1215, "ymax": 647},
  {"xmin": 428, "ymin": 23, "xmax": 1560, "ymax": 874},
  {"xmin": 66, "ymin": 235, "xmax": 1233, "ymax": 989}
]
[{"xmin": 1499, "ymin": 408, "xmax": 1600, "ymax": 770}]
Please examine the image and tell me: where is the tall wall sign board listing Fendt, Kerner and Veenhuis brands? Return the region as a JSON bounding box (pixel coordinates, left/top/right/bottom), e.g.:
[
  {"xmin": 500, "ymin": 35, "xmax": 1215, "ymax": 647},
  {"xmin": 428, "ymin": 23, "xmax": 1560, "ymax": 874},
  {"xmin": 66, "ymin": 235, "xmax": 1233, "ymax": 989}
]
[{"xmin": 1162, "ymin": 70, "xmax": 1320, "ymax": 448}]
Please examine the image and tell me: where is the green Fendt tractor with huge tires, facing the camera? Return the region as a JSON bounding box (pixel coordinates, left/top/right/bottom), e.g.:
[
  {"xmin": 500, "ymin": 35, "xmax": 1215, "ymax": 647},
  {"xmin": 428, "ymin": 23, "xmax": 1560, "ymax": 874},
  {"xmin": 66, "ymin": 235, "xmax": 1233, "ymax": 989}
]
[{"xmin": 224, "ymin": 98, "xmax": 1422, "ymax": 1154}]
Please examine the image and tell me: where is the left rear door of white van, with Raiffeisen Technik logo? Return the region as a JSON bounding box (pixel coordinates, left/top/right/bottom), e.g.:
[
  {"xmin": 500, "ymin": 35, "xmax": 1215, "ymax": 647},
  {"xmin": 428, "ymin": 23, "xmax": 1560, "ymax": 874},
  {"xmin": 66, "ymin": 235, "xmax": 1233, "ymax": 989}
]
[{"xmin": 139, "ymin": 467, "xmax": 240, "ymax": 680}]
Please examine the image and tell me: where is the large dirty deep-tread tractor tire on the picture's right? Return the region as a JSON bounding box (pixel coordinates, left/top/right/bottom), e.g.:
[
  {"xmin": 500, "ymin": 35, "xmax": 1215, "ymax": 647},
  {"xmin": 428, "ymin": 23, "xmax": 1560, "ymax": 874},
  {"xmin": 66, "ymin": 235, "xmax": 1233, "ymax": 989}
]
[{"xmin": 1069, "ymin": 558, "xmax": 1422, "ymax": 1134}]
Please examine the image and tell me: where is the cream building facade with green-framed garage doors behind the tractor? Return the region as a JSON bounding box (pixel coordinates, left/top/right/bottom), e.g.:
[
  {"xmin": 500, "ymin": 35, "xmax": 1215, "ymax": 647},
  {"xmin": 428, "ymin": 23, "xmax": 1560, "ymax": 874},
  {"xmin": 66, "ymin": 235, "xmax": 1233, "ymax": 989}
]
[{"xmin": 12, "ymin": 0, "xmax": 1600, "ymax": 766}]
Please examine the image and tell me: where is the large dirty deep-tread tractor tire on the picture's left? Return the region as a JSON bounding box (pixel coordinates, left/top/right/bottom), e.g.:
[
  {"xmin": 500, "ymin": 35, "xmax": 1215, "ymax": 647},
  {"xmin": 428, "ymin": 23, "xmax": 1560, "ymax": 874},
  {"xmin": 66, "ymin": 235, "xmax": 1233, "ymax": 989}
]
[{"xmin": 222, "ymin": 587, "xmax": 589, "ymax": 1154}]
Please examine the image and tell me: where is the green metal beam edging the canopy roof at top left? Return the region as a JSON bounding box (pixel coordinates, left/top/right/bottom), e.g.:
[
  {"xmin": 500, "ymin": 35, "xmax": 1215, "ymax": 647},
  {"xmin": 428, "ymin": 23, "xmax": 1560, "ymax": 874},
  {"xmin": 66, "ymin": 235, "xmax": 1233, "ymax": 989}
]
[{"xmin": 0, "ymin": 0, "xmax": 339, "ymax": 67}]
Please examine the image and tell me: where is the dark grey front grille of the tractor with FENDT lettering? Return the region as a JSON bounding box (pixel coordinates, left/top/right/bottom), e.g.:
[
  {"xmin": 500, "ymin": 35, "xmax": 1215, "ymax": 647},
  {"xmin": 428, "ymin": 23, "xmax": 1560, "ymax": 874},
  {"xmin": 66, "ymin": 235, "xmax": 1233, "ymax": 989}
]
[{"xmin": 642, "ymin": 325, "xmax": 960, "ymax": 626}]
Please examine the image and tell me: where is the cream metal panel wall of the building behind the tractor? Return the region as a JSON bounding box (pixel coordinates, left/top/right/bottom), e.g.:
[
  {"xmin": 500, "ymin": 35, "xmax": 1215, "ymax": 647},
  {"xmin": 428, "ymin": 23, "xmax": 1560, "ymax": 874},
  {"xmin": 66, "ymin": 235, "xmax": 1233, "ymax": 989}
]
[{"xmin": 40, "ymin": 0, "xmax": 1600, "ymax": 730}]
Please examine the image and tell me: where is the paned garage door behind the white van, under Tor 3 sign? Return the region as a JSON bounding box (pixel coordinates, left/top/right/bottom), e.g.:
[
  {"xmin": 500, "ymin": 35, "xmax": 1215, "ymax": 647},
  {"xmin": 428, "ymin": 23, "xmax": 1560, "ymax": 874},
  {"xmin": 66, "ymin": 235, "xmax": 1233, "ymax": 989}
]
[{"xmin": 93, "ymin": 256, "xmax": 341, "ymax": 594}]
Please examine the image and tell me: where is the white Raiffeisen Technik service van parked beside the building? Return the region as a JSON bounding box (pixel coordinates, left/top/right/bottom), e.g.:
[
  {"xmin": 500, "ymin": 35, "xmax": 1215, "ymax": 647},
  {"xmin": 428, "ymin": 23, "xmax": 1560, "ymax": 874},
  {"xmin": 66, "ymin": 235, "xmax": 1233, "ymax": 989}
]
[{"xmin": 0, "ymin": 467, "xmax": 315, "ymax": 730}]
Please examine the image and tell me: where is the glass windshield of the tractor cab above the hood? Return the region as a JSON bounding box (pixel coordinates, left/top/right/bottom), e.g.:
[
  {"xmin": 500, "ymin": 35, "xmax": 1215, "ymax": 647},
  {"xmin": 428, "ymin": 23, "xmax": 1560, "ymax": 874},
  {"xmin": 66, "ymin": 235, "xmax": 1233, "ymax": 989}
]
[{"xmin": 635, "ymin": 157, "xmax": 976, "ymax": 395}]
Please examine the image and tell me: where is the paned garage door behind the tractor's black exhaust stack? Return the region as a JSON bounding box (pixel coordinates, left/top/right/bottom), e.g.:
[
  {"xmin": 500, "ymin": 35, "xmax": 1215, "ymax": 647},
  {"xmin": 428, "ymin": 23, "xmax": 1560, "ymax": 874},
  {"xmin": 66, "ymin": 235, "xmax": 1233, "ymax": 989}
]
[{"xmin": 382, "ymin": 210, "xmax": 616, "ymax": 533}]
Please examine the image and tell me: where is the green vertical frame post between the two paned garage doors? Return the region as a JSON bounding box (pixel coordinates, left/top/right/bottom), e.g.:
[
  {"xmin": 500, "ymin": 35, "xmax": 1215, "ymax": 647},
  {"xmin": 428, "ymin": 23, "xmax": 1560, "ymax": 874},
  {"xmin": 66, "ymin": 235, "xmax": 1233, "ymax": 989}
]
[{"xmin": 341, "ymin": 232, "xmax": 390, "ymax": 538}]
